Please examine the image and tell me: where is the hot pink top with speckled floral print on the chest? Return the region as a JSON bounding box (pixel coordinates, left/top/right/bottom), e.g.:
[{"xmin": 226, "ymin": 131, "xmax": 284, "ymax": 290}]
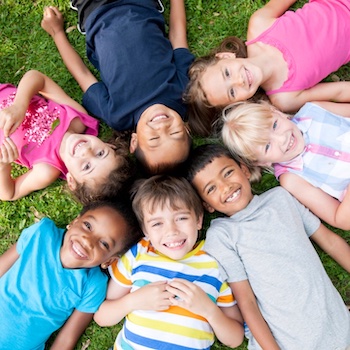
[{"xmin": 0, "ymin": 84, "xmax": 98, "ymax": 179}]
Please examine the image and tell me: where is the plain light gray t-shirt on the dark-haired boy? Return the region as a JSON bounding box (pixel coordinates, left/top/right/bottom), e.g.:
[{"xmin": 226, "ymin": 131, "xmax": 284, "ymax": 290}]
[{"xmin": 204, "ymin": 187, "xmax": 350, "ymax": 350}]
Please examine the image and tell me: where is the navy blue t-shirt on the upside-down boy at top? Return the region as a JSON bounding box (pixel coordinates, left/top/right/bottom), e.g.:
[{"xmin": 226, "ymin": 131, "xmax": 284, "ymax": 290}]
[{"xmin": 83, "ymin": 0, "xmax": 194, "ymax": 130}]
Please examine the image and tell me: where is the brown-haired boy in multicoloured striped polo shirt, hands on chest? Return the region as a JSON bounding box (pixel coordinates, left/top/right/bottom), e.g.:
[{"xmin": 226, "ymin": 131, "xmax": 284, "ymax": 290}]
[{"xmin": 94, "ymin": 175, "xmax": 244, "ymax": 350}]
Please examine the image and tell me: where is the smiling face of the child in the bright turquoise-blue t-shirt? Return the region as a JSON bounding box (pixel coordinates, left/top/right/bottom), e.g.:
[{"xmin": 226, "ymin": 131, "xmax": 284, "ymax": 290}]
[{"xmin": 60, "ymin": 207, "xmax": 128, "ymax": 269}]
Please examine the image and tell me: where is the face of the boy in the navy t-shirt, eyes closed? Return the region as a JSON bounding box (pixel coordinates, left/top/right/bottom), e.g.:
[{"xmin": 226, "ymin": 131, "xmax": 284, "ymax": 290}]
[{"xmin": 130, "ymin": 104, "xmax": 190, "ymax": 170}]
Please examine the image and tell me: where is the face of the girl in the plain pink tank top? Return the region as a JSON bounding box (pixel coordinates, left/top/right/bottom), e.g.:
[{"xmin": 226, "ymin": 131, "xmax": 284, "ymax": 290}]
[{"xmin": 201, "ymin": 52, "xmax": 261, "ymax": 106}]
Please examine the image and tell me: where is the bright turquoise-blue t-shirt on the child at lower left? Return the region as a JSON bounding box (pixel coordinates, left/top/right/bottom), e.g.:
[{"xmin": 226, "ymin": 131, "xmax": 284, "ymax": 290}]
[{"xmin": 0, "ymin": 218, "xmax": 107, "ymax": 350}]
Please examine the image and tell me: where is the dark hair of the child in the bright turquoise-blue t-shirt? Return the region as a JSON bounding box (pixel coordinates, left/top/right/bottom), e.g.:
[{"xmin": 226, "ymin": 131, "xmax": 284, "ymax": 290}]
[{"xmin": 80, "ymin": 195, "xmax": 143, "ymax": 256}]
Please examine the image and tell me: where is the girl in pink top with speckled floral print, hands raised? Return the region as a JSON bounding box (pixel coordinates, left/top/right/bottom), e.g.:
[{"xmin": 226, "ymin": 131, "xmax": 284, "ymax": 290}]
[{"xmin": 0, "ymin": 70, "xmax": 131, "ymax": 203}]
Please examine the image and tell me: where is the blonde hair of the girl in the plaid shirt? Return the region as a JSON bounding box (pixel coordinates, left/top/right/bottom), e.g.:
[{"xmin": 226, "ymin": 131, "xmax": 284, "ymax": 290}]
[{"xmin": 221, "ymin": 101, "xmax": 276, "ymax": 164}]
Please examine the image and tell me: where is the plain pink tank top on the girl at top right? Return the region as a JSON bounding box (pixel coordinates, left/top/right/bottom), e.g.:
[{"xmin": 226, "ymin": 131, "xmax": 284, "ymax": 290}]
[{"xmin": 246, "ymin": 0, "xmax": 350, "ymax": 95}]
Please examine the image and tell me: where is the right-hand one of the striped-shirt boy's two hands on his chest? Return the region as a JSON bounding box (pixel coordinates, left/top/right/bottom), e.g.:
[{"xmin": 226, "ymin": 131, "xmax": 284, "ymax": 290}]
[{"xmin": 167, "ymin": 278, "xmax": 214, "ymax": 317}]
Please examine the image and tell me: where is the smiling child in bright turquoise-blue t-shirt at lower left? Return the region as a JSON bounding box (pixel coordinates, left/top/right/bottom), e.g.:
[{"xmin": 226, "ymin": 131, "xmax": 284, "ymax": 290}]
[{"xmin": 0, "ymin": 202, "xmax": 141, "ymax": 350}]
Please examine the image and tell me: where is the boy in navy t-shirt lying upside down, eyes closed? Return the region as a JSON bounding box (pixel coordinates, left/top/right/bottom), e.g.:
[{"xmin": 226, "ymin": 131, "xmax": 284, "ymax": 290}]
[{"xmin": 41, "ymin": 0, "xmax": 194, "ymax": 173}]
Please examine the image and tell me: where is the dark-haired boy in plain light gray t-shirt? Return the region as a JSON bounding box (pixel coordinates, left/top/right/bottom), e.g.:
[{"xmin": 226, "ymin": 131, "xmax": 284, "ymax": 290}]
[{"xmin": 187, "ymin": 145, "xmax": 350, "ymax": 350}]
